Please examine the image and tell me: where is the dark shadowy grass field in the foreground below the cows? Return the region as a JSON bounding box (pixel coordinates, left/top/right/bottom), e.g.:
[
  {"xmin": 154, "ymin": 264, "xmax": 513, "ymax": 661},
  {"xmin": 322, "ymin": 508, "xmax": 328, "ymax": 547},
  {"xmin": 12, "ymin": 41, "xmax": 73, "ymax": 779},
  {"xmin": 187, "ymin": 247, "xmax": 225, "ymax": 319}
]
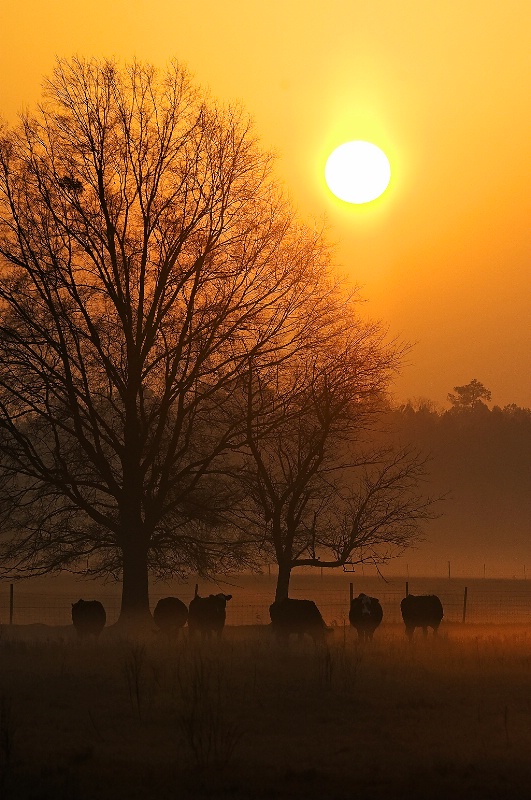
[{"xmin": 0, "ymin": 624, "xmax": 531, "ymax": 800}]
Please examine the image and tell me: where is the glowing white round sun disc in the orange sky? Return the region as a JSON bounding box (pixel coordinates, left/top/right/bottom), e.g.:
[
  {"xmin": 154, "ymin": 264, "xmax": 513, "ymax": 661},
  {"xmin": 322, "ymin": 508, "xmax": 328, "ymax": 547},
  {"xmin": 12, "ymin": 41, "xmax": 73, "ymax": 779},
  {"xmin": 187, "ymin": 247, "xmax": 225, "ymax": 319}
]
[{"xmin": 325, "ymin": 140, "xmax": 391, "ymax": 203}]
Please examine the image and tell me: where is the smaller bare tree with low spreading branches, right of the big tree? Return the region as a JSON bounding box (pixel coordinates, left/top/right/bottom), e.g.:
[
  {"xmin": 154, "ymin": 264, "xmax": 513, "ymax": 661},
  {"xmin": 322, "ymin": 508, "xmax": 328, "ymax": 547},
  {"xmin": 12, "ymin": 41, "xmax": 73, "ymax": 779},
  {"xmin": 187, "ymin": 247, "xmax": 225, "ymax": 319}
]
[{"xmin": 235, "ymin": 318, "xmax": 433, "ymax": 600}]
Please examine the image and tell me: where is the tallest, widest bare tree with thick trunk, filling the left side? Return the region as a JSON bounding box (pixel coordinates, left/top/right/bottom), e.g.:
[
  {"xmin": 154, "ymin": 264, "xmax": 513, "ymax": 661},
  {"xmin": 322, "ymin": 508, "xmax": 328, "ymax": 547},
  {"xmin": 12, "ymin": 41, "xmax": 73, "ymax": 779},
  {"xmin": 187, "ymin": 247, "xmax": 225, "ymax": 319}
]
[{"xmin": 0, "ymin": 60, "xmax": 333, "ymax": 619}]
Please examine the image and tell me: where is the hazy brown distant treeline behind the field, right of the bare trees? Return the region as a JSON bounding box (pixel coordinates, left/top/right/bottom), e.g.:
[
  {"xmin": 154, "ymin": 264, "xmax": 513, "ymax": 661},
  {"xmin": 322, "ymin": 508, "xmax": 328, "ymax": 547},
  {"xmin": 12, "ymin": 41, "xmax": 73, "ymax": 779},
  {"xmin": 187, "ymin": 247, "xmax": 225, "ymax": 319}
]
[{"xmin": 386, "ymin": 381, "xmax": 531, "ymax": 569}]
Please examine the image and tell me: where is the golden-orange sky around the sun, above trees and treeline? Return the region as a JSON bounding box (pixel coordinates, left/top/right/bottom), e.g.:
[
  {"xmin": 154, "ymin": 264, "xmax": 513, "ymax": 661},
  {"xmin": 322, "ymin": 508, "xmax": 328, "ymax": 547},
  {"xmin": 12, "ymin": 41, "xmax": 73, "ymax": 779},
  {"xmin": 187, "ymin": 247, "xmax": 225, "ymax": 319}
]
[{"xmin": 0, "ymin": 0, "xmax": 531, "ymax": 407}]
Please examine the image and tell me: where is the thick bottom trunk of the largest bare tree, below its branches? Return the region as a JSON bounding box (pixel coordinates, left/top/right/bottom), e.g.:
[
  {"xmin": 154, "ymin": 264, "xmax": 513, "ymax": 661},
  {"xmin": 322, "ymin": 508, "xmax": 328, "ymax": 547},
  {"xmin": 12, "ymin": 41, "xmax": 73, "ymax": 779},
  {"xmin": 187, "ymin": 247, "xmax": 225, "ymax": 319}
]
[{"xmin": 118, "ymin": 541, "xmax": 152, "ymax": 624}]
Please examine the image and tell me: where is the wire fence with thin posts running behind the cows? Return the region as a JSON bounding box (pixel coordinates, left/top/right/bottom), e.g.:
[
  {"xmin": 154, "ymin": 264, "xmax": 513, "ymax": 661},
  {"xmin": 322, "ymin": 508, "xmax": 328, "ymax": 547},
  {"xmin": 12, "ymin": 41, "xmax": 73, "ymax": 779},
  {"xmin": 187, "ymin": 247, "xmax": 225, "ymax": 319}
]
[{"xmin": 0, "ymin": 581, "xmax": 531, "ymax": 626}]
